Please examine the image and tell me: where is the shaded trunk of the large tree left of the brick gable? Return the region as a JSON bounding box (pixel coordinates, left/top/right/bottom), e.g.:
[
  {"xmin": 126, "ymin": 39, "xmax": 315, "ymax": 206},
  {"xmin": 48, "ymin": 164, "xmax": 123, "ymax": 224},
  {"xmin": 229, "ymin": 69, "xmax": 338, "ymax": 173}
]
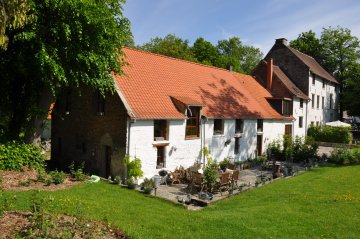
[{"xmin": 25, "ymin": 87, "xmax": 54, "ymax": 145}]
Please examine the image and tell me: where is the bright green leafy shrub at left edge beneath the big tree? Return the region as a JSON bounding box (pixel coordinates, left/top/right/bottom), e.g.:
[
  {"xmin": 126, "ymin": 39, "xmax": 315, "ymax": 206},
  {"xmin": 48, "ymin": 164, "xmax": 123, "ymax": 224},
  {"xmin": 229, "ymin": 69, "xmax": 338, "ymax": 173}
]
[{"xmin": 0, "ymin": 141, "xmax": 44, "ymax": 171}]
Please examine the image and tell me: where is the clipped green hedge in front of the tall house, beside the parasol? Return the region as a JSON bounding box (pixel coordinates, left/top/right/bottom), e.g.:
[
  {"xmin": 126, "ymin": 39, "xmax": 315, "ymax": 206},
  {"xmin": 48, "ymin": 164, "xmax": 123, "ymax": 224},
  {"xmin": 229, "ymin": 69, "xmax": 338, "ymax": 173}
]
[{"xmin": 308, "ymin": 126, "xmax": 352, "ymax": 144}]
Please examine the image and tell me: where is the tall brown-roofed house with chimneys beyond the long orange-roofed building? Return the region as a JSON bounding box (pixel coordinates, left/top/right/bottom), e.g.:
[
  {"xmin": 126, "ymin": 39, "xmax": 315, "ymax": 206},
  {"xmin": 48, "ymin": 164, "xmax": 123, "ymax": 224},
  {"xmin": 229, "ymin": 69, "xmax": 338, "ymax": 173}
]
[{"xmin": 253, "ymin": 38, "xmax": 339, "ymax": 136}]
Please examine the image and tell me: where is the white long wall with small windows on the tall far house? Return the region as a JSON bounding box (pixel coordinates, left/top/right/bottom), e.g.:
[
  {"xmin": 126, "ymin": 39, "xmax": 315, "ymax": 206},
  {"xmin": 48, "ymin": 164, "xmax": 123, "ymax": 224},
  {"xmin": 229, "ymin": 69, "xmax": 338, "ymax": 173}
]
[{"xmin": 307, "ymin": 74, "xmax": 339, "ymax": 126}]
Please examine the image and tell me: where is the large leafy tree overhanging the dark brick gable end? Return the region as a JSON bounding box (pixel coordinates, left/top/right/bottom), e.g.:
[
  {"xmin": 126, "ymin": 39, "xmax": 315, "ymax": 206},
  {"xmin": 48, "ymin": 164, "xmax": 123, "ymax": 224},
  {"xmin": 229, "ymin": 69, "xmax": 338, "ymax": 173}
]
[{"xmin": 0, "ymin": 0, "xmax": 131, "ymax": 141}]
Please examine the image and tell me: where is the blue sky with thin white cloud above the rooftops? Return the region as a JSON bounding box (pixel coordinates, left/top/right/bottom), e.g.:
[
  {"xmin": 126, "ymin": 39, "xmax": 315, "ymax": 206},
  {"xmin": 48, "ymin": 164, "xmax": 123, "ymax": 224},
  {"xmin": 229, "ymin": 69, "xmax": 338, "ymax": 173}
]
[{"xmin": 124, "ymin": 0, "xmax": 360, "ymax": 54}]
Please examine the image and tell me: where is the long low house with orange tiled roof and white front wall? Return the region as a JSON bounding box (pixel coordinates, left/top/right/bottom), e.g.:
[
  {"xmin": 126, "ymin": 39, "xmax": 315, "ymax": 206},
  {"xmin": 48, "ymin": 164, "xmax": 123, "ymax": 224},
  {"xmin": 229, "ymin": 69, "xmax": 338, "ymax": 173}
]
[{"xmin": 52, "ymin": 48, "xmax": 294, "ymax": 177}]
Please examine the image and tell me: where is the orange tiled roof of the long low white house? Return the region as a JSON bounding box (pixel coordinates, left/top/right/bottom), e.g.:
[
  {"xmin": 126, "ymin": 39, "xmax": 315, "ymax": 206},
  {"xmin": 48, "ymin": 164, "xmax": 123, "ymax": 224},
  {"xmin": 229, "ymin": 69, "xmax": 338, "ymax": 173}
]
[{"xmin": 114, "ymin": 48, "xmax": 292, "ymax": 119}]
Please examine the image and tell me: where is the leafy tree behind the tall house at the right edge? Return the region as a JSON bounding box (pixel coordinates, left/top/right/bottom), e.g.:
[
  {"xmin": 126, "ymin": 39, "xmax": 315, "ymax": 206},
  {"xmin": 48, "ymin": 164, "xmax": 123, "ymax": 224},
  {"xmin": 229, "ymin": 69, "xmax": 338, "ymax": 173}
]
[{"xmin": 290, "ymin": 26, "xmax": 360, "ymax": 119}]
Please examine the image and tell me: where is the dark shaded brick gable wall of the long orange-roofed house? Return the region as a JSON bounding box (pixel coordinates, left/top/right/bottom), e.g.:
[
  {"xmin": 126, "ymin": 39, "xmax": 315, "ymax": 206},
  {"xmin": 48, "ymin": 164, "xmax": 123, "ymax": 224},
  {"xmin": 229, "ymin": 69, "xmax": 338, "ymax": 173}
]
[{"xmin": 52, "ymin": 88, "xmax": 127, "ymax": 177}]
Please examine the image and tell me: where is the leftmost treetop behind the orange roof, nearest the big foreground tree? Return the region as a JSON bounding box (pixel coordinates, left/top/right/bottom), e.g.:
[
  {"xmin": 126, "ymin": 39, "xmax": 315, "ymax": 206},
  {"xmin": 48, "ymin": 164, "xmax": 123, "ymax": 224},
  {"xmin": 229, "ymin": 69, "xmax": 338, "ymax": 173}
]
[{"xmin": 138, "ymin": 34, "xmax": 195, "ymax": 61}]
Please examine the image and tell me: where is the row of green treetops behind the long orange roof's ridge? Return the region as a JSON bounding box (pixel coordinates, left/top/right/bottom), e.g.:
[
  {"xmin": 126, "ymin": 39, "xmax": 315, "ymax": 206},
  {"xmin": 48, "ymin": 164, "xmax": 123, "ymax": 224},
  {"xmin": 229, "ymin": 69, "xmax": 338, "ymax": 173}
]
[{"xmin": 138, "ymin": 34, "xmax": 263, "ymax": 74}]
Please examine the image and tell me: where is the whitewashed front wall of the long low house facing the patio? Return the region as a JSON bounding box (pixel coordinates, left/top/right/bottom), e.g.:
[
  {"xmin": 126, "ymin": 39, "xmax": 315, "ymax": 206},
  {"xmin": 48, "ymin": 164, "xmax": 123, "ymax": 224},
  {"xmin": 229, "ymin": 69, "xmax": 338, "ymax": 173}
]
[{"xmin": 129, "ymin": 116, "xmax": 285, "ymax": 178}]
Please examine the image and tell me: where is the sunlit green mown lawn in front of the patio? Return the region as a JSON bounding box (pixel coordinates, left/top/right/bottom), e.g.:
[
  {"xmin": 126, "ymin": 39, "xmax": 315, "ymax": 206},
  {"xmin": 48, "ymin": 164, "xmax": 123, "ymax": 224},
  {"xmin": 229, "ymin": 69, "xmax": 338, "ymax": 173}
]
[{"xmin": 2, "ymin": 166, "xmax": 360, "ymax": 238}]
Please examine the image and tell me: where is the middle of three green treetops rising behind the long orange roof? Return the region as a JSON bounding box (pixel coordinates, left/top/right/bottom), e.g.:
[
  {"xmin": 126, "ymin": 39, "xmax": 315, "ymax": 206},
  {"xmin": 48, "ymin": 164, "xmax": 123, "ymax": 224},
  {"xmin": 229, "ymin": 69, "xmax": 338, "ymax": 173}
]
[{"xmin": 192, "ymin": 37, "xmax": 220, "ymax": 66}]
